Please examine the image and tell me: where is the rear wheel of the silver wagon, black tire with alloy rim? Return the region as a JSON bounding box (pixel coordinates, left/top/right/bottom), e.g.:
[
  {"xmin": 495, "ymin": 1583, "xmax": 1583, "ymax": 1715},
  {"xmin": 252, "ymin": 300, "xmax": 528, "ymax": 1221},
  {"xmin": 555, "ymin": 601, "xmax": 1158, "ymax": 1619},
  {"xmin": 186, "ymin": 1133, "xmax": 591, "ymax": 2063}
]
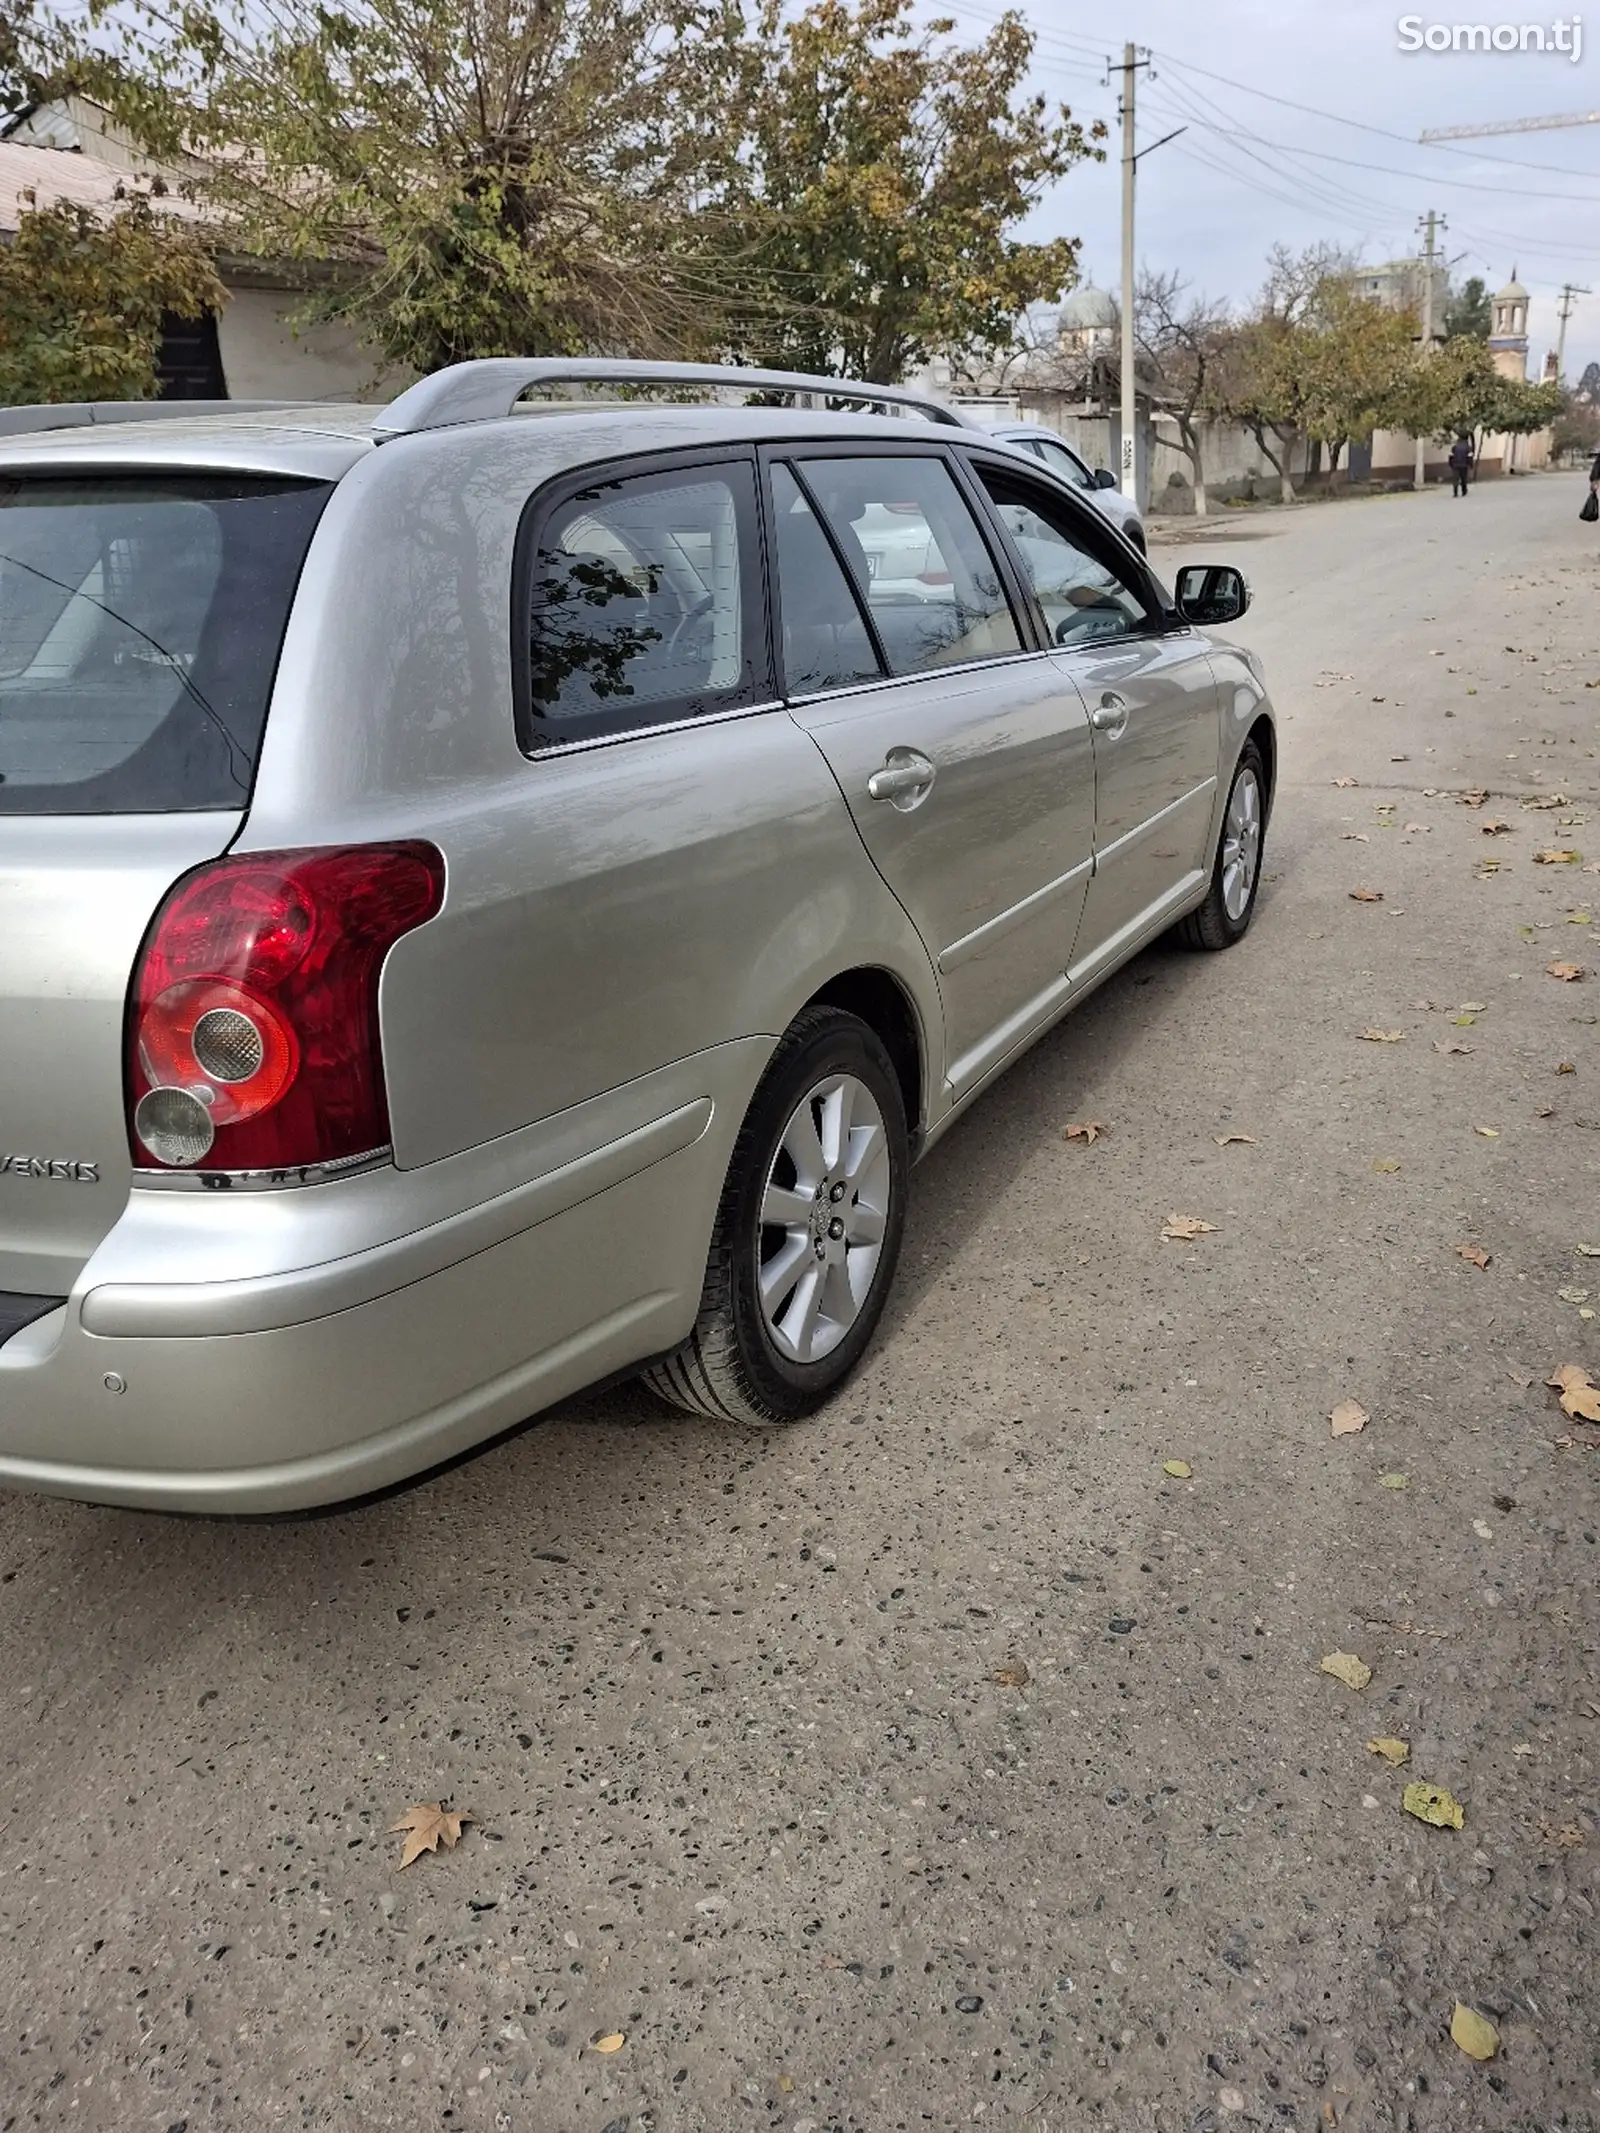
[{"xmin": 644, "ymin": 1007, "xmax": 911, "ymax": 1427}]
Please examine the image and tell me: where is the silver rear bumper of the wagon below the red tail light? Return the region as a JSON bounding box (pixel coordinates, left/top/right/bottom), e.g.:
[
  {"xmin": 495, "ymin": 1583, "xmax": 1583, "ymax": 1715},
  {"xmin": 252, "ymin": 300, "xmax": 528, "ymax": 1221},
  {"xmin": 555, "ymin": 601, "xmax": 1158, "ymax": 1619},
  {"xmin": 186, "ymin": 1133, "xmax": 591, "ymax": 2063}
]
[{"xmin": 0, "ymin": 1041, "xmax": 770, "ymax": 1514}]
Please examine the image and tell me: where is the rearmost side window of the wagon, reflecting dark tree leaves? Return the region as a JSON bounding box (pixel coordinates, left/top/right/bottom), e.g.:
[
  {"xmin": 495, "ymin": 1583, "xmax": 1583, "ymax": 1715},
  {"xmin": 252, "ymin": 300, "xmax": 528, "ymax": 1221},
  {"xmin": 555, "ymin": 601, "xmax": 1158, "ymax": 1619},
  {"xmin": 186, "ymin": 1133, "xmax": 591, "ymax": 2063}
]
[{"xmin": 523, "ymin": 465, "xmax": 759, "ymax": 749}]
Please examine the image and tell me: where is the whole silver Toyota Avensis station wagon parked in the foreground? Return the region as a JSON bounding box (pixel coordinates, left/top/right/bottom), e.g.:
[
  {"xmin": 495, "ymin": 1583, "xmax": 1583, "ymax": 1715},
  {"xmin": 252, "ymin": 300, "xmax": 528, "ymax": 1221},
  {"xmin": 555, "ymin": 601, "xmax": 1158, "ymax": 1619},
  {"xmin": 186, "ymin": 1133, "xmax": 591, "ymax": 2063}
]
[{"xmin": 0, "ymin": 360, "xmax": 1278, "ymax": 1512}]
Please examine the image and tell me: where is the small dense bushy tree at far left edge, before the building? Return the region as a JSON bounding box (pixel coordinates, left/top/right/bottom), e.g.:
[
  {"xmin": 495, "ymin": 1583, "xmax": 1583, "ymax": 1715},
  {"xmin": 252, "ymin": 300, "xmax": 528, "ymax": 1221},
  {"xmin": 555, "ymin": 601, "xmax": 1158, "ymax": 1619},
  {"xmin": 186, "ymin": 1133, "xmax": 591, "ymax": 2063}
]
[{"xmin": 0, "ymin": 194, "xmax": 224, "ymax": 405}]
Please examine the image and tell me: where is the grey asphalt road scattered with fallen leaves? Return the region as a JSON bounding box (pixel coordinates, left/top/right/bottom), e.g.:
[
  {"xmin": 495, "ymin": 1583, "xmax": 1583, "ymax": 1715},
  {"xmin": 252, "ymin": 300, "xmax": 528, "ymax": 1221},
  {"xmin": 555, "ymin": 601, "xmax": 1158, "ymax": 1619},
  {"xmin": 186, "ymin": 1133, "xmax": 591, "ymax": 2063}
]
[{"xmin": 0, "ymin": 478, "xmax": 1600, "ymax": 2133}]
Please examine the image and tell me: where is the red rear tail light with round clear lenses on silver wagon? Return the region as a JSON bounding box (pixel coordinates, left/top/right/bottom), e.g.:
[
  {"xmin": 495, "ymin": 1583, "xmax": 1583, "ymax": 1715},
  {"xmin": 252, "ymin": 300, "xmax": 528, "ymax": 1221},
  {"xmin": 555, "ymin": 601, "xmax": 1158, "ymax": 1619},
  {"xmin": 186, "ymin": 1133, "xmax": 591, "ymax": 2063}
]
[{"xmin": 128, "ymin": 843, "xmax": 444, "ymax": 1171}]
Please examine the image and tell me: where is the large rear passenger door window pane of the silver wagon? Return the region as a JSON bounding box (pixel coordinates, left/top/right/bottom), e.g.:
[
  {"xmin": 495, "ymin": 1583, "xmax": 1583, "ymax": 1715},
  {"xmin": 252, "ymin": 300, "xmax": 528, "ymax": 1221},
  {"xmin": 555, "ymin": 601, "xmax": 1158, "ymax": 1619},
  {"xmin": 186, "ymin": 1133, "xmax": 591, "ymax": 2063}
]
[{"xmin": 800, "ymin": 452, "xmax": 1022, "ymax": 674}]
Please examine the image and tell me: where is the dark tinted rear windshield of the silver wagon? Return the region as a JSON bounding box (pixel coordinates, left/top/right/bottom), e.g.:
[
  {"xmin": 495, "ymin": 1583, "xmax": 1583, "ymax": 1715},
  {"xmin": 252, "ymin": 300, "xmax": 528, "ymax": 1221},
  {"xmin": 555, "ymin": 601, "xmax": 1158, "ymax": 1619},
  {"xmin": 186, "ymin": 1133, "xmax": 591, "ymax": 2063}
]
[{"xmin": 0, "ymin": 474, "xmax": 333, "ymax": 815}]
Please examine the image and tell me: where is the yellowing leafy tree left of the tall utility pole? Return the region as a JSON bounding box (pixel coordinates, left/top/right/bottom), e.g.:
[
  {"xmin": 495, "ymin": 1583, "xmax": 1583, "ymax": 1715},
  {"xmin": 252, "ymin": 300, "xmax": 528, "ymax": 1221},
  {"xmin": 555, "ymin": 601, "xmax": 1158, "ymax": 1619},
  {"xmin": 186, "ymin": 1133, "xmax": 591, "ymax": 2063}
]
[{"xmin": 740, "ymin": 0, "xmax": 1105, "ymax": 384}]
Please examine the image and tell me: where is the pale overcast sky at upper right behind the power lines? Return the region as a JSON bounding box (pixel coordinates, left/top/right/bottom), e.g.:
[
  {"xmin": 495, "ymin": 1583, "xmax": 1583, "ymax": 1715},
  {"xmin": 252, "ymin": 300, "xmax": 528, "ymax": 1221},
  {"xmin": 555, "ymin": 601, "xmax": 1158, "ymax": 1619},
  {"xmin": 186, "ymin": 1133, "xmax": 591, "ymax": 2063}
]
[{"xmin": 939, "ymin": 0, "xmax": 1600, "ymax": 380}]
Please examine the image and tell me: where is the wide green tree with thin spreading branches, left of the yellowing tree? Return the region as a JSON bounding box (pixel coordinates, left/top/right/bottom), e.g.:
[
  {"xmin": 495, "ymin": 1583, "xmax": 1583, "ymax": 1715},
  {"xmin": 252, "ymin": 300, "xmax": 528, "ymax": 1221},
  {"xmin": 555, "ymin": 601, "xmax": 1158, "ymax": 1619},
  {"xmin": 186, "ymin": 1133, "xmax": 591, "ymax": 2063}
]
[{"xmin": 62, "ymin": 0, "xmax": 759, "ymax": 371}]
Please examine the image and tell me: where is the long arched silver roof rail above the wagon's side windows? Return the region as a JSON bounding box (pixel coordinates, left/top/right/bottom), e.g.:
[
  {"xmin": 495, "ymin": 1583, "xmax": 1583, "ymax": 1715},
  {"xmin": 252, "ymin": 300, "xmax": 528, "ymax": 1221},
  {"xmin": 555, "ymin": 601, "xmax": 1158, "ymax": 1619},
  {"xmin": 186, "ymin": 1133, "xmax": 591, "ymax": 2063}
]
[{"xmin": 373, "ymin": 356, "xmax": 977, "ymax": 442}]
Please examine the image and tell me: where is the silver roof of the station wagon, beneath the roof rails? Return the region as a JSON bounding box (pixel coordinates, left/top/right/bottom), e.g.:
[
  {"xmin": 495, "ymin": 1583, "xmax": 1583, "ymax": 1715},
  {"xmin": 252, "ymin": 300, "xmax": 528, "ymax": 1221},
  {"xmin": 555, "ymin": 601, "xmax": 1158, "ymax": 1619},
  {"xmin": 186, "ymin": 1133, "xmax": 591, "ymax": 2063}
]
[{"xmin": 0, "ymin": 399, "xmax": 1019, "ymax": 482}]
